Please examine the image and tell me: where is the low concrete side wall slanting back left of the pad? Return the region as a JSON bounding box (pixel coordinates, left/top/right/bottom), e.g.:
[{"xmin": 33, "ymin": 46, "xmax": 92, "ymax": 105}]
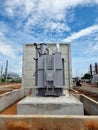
[{"xmin": 0, "ymin": 89, "xmax": 24, "ymax": 112}]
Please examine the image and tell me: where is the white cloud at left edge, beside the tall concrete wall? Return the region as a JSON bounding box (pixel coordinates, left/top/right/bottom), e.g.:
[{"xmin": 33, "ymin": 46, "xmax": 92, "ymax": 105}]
[{"xmin": 0, "ymin": 24, "xmax": 22, "ymax": 59}]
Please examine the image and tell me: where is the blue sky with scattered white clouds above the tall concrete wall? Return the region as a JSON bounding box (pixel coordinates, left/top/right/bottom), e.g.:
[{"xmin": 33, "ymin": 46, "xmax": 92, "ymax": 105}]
[{"xmin": 0, "ymin": 0, "xmax": 98, "ymax": 76}]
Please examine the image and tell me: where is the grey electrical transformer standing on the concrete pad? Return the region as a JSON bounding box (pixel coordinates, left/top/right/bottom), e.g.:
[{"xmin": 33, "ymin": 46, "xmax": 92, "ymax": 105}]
[{"xmin": 35, "ymin": 43, "xmax": 65, "ymax": 96}]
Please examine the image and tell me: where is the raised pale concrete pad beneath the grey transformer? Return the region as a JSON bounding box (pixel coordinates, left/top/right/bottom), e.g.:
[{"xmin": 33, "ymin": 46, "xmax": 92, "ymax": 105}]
[{"xmin": 17, "ymin": 96, "xmax": 84, "ymax": 115}]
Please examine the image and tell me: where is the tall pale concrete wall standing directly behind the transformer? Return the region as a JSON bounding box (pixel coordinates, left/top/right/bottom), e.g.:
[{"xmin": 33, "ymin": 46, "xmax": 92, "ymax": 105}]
[{"xmin": 22, "ymin": 44, "xmax": 72, "ymax": 88}]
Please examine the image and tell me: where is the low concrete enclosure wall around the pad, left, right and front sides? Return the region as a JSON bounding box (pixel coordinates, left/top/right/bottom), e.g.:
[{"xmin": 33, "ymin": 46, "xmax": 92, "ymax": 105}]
[{"xmin": 0, "ymin": 89, "xmax": 98, "ymax": 130}]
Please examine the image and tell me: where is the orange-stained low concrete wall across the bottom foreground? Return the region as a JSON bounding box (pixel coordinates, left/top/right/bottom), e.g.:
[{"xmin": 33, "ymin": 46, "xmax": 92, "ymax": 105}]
[{"xmin": 0, "ymin": 115, "xmax": 98, "ymax": 130}]
